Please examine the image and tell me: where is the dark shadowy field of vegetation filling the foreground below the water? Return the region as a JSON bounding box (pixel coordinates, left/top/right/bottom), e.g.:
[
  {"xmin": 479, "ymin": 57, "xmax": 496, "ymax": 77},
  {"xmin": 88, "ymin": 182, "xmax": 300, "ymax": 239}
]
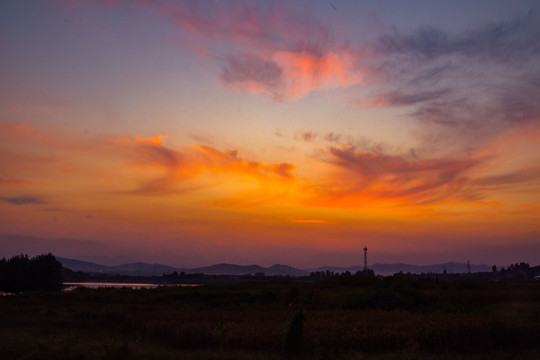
[{"xmin": 0, "ymin": 275, "xmax": 540, "ymax": 359}]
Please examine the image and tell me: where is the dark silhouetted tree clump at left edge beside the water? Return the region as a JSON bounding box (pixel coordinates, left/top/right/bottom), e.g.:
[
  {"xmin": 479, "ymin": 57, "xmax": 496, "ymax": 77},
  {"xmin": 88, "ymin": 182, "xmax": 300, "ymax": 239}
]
[{"xmin": 0, "ymin": 253, "xmax": 62, "ymax": 292}]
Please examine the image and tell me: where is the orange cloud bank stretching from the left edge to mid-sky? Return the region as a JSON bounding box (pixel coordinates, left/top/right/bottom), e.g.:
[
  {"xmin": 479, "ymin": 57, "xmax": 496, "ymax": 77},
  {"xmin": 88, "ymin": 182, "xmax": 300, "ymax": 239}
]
[{"xmin": 0, "ymin": 122, "xmax": 308, "ymax": 211}]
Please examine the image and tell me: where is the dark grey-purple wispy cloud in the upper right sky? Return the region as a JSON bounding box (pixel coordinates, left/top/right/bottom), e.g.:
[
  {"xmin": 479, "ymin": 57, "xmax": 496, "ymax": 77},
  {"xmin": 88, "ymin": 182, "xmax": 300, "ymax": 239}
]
[{"xmin": 368, "ymin": 15, "xmax": 540, "ymax": 143}]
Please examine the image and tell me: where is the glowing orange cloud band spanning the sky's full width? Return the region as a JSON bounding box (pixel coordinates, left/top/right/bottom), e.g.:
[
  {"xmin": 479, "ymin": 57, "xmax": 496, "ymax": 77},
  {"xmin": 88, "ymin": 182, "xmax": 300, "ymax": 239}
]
[{"xmin": 0, "ymin": 119, "xmax": 539, "ymax": 231}]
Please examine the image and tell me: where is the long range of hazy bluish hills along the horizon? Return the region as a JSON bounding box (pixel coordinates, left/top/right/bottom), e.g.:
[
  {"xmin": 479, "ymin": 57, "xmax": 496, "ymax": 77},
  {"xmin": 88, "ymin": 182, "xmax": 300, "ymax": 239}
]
[{"xmin": 57, "ymin": 257, "xmax": 491, "ymax": 276}]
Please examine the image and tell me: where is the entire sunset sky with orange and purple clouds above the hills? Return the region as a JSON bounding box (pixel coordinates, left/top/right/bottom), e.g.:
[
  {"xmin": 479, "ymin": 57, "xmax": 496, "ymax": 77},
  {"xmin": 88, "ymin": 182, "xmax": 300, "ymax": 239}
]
[{"xmin": 0, "ymin": 0, "xmax": 540, "ymax": 268}]
